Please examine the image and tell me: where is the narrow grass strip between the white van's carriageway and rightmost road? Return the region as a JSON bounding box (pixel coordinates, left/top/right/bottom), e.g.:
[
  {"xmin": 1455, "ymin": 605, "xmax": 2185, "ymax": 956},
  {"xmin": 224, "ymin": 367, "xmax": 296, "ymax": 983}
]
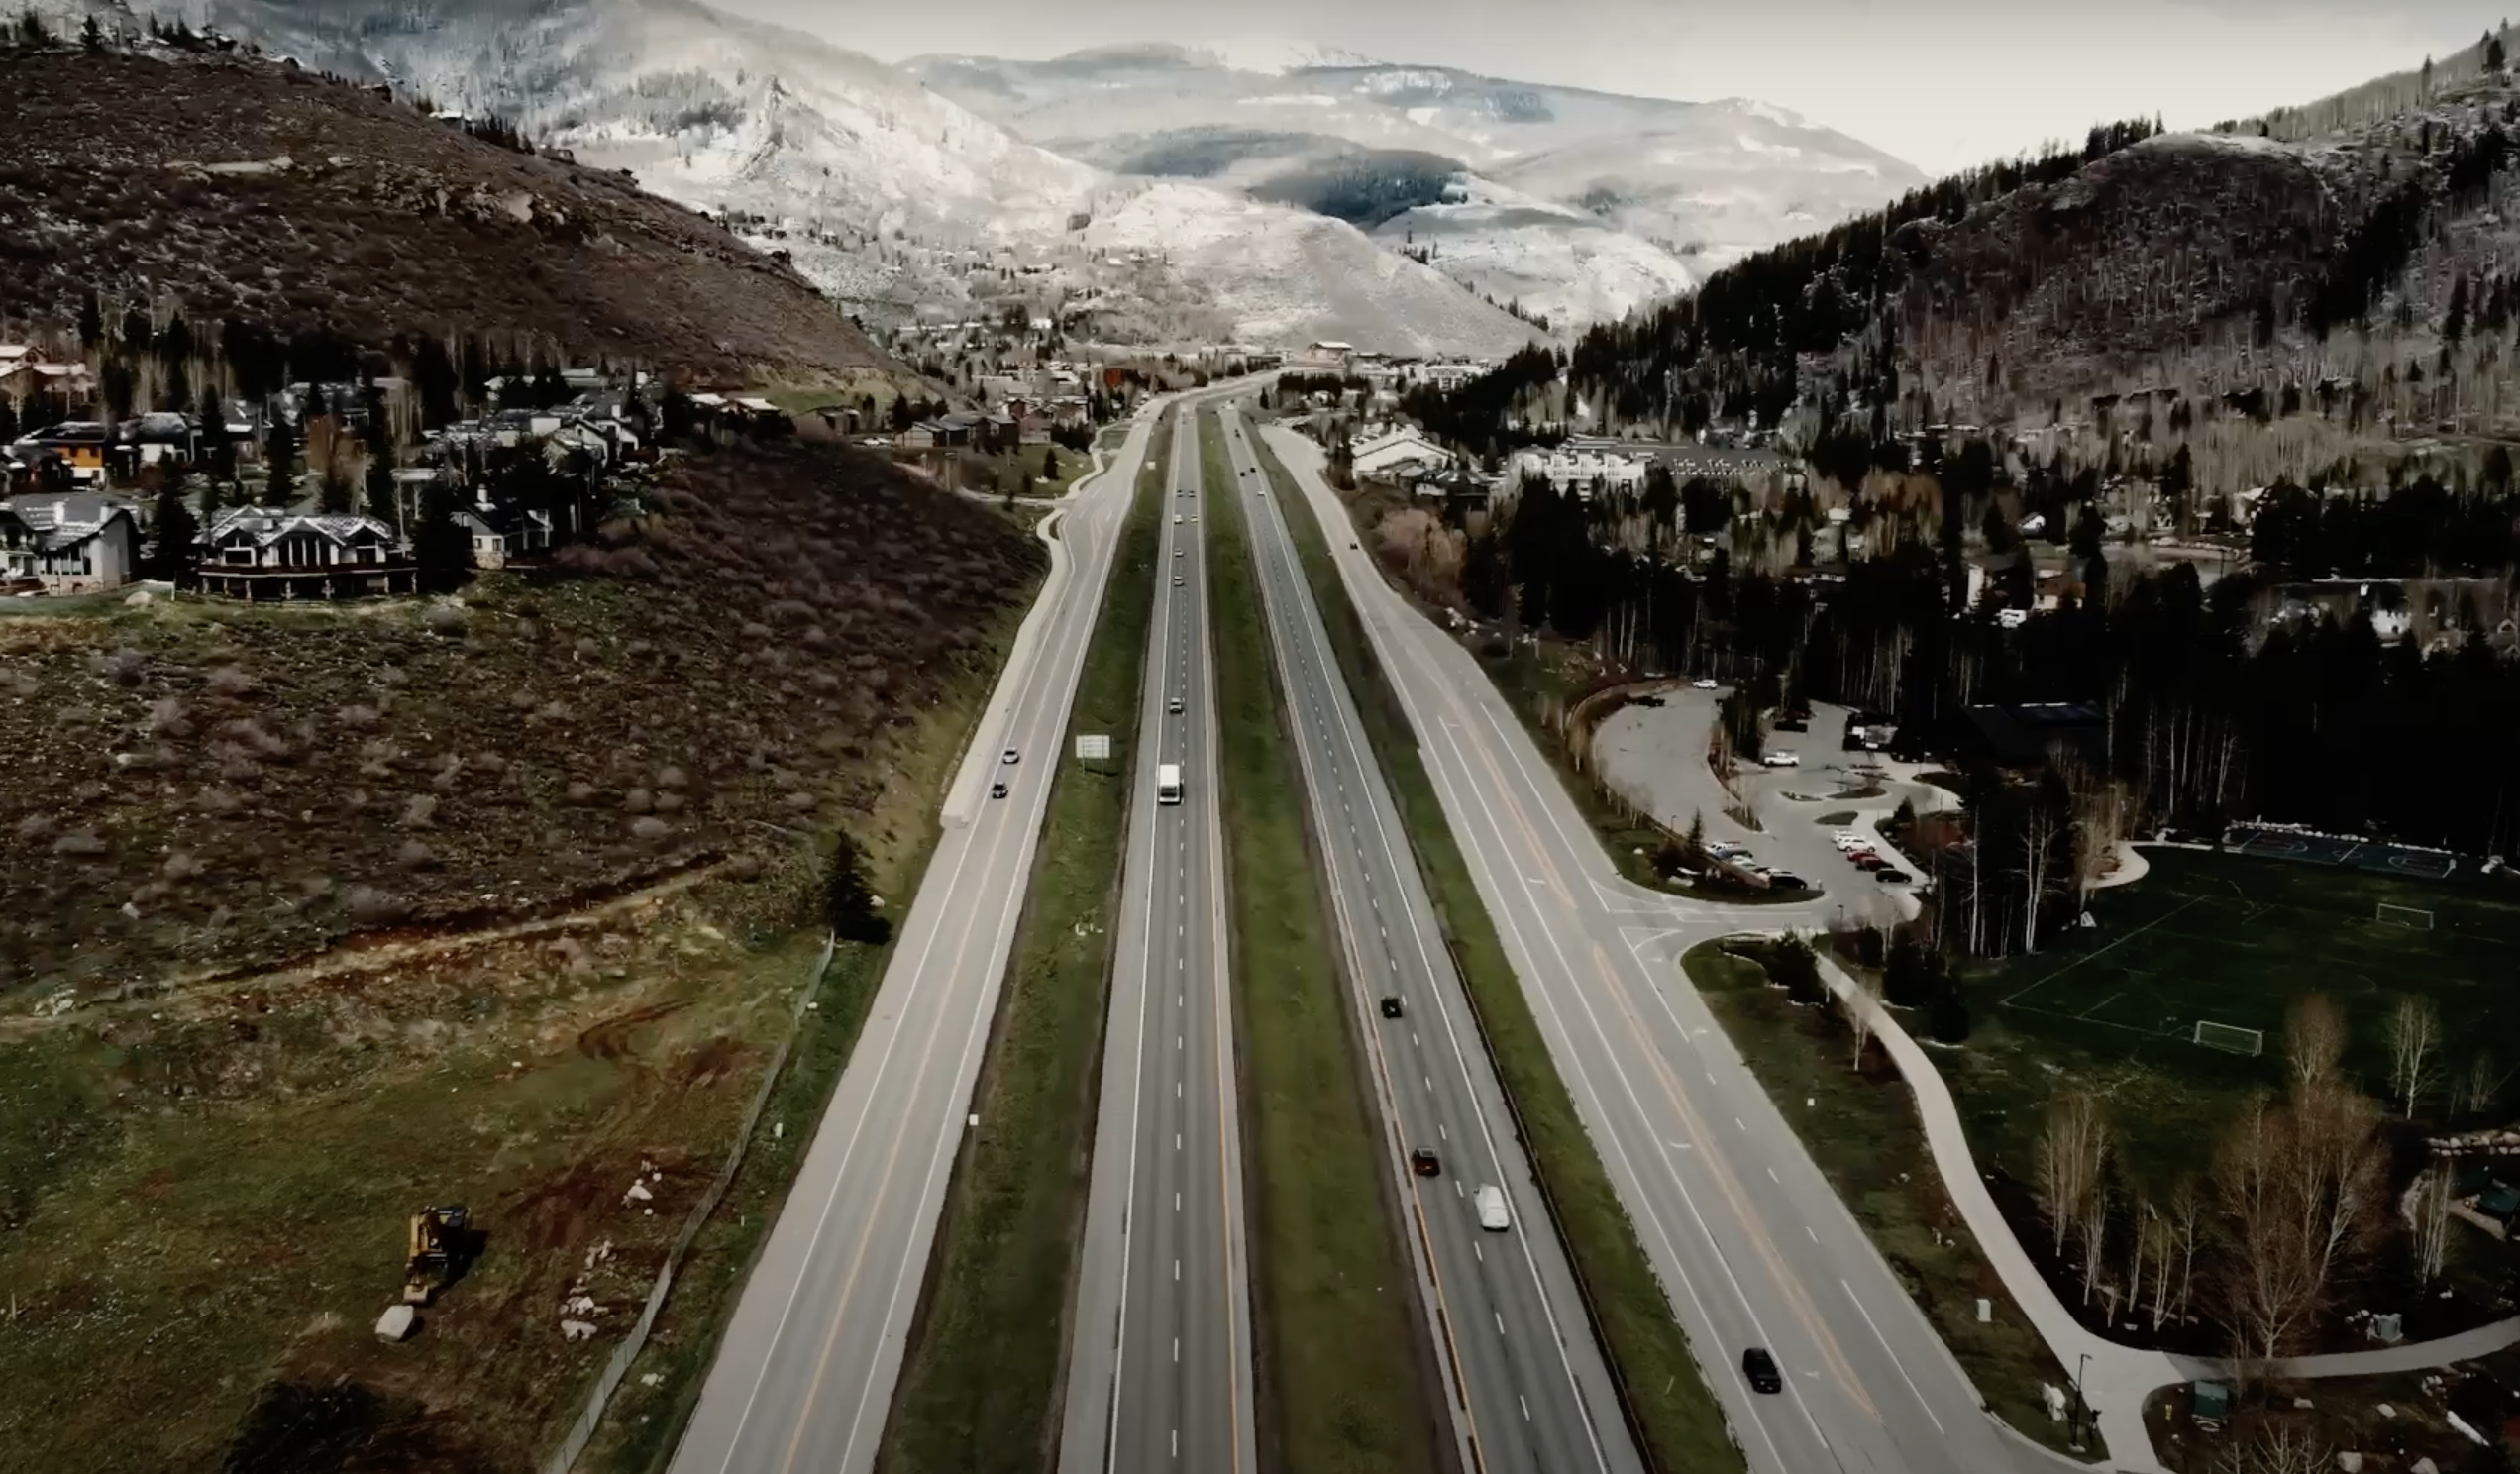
[{"xmin": 1252, "ymin": 423, "xmax": 1741, "ymax": 1471}]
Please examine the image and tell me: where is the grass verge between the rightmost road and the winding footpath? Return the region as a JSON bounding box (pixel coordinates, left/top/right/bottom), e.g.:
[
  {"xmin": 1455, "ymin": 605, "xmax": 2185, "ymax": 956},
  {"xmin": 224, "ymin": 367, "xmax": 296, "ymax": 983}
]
[{"xmin": 1681, "ymin": 942, "xmax": 2104, "ymax": 1459}]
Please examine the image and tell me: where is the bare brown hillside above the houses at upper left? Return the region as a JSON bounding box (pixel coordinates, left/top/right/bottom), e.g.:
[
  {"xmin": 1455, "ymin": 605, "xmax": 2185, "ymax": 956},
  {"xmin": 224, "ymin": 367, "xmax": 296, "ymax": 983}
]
[{"xmin": 0, "ymin": 48, "xmax": 882, "ymax": 375}]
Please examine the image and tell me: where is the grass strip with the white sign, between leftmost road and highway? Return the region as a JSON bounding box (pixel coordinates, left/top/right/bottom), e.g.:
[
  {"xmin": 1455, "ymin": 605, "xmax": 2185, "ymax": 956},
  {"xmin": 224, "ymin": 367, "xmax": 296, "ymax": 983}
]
[{"xmin": 877, "ymin": 405, "xmax": 1169, "ymax": 1474}]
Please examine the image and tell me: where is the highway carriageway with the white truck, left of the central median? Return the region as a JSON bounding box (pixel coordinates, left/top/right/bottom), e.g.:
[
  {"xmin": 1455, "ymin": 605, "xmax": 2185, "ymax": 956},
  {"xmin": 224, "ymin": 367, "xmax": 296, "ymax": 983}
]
[{"xmin": 1058, "ymin": 411, "xmax": 1257, "ymax": 1474}]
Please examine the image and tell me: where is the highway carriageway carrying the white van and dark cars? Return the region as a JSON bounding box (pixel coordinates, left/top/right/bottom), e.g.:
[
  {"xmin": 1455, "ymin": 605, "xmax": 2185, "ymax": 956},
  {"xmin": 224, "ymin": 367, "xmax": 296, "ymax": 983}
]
[{"xmin": 1222, "ymin": 408, "xmax": 1643, "ymax": 1474}]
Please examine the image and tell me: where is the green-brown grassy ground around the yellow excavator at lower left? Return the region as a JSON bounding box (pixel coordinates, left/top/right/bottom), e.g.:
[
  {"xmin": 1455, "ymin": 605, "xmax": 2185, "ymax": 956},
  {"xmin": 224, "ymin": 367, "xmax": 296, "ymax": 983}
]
[{"xmin": 0, "ymin": 591, "xmax": 1020, "ymax": 1474}]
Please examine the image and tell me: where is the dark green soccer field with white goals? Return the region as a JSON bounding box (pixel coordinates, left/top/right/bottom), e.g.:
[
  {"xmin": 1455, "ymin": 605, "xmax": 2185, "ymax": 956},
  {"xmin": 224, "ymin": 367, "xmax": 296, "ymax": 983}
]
[{"xmin": 1978, "ymin": 849, "xmax": 2520, "ymax": 1076}]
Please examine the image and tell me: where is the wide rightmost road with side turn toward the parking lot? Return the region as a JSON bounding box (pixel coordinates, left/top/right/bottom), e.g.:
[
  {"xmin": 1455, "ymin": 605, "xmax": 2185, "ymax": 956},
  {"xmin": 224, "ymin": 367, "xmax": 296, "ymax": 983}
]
[{"xmin": 1263, "ymin": 415, "xmax": 2086, "ymax": 1474}]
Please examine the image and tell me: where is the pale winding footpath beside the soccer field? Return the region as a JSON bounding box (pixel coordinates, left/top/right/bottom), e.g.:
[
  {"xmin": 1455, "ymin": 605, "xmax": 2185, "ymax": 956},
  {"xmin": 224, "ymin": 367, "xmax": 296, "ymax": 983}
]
[{"xmin": 1820, "ymin": 952, "xmax": 2520, "ymax": 1474}]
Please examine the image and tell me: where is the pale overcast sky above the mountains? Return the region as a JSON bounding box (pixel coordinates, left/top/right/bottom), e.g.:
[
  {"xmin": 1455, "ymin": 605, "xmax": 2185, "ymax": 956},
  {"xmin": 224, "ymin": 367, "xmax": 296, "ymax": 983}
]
[{"xmin": 713, "ymin": 0, "xmax": 2507, "ymax": 174}]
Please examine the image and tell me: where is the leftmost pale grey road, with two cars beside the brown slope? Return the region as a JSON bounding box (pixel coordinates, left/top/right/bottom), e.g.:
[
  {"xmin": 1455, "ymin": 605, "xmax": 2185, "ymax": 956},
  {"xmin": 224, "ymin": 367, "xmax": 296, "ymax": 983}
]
[{"xmin": 673, "ymin": 402, "xmax": 1179, "ymax": 1474}]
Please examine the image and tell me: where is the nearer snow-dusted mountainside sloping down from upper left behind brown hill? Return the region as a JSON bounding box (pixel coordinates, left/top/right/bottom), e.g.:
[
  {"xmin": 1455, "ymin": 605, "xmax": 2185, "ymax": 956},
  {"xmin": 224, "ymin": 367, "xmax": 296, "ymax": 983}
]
[{"xmin": 63, "ymin": 0, "xmax": 1534, "ymax": 356}]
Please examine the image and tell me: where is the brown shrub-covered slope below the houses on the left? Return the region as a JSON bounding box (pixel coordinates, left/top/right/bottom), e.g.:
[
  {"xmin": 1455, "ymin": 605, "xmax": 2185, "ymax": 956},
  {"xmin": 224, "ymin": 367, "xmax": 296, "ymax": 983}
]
[{"xmin": 0, "ymin": 446, "xmax": 1043, "ymax": 1005}]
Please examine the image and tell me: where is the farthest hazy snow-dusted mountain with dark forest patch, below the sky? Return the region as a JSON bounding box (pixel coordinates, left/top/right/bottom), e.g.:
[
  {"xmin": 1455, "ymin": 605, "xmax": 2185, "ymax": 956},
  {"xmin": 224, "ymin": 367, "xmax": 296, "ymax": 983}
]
[{"xmin": 904, "ymin": 46, "xmax": 1926, "ymax": 323}]
